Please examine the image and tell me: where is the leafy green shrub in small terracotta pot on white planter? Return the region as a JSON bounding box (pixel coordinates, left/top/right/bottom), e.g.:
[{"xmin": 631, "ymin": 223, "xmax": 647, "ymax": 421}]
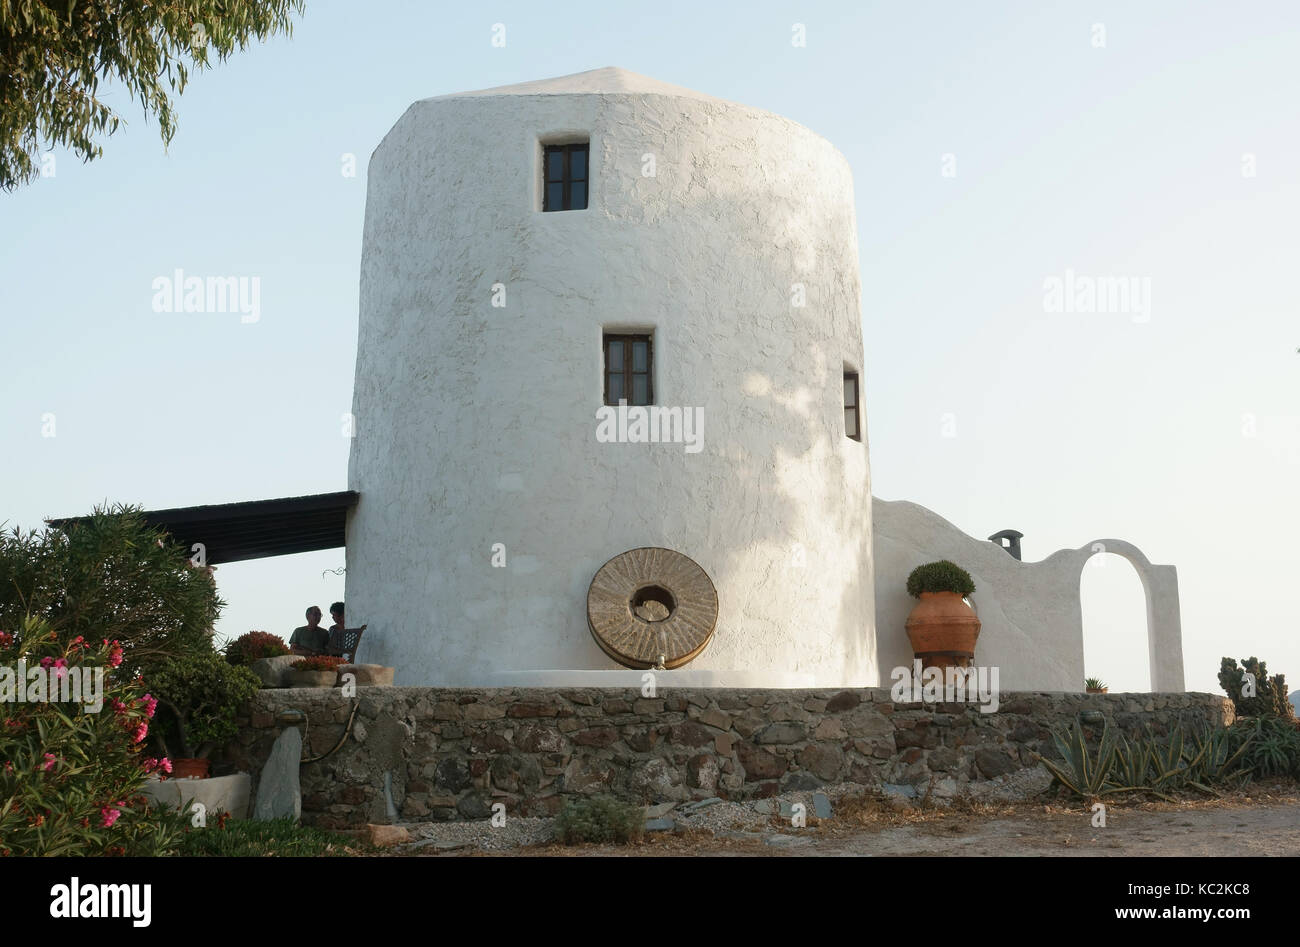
[{"xmin": 148, "ymin": 650, "xmax": 261, "ymax": 779}]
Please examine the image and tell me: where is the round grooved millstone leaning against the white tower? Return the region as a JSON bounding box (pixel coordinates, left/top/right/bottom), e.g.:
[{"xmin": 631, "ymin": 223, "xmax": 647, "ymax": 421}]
[{"xmin": 586, "ymin": 546, "xmax": 718, "ymax": 669}]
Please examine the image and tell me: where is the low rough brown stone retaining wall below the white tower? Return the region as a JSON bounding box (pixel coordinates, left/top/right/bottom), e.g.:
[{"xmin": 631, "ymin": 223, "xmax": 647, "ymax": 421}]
[{"xmin": 225, "ymin": 687, "xmax": 1232, "ymax": 827}]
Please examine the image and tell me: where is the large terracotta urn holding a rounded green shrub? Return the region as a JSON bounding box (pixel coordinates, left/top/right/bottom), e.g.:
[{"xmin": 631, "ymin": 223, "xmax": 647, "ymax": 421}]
[{"xmin": 907, "ymin": 559, "xmax": 980, "ymax": 667}]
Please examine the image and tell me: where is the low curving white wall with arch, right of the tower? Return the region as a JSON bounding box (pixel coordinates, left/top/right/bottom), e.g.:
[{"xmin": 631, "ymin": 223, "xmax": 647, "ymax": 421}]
[{"xmin": 872, "ymin": 498, "xmax": 1184, "ymax": 692}]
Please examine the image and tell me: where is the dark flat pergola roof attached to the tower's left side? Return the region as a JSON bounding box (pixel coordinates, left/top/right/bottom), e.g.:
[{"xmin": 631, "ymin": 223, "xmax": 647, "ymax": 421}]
[{"xmin": 49, "ymin": 490, "xmax": 360, "ymax": 566}]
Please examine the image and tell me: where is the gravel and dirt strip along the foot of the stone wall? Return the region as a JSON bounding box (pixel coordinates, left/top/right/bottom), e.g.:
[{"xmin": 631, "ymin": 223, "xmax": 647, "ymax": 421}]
[{"xmin": 393, "ymin": 787, "xmax": 1300, "ymax": 857}]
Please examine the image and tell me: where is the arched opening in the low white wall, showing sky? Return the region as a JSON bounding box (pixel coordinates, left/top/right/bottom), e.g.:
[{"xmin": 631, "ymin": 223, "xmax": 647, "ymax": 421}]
[{"xmin": 1079, "ymin": 552, "xmax": 1151, "ymax": 693}]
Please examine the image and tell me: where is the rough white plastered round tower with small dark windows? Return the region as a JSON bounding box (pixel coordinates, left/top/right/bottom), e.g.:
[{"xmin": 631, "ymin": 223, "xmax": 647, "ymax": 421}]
[{"xmin": 347, "ymin": 69, "xmax": 873, "ymax": 687}]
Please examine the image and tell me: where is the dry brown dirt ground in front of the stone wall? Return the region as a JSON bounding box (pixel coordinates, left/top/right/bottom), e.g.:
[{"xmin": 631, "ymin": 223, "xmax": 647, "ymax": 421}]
[{"xmin": 442, "ymin": 786, "xmax": 1300, "ymax": 857}]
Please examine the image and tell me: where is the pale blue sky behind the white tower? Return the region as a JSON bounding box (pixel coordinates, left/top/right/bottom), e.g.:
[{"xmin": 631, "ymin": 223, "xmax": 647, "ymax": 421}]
[{"xmin": 0, "ymin": 0, "xmax": 1300, "ymax": 689}]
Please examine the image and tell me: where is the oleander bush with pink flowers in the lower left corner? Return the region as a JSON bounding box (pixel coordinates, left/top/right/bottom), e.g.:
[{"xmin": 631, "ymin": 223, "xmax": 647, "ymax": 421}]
[{"xmin": 0, "ymin": 617, "xmax": 186, "ymax": 856}]
